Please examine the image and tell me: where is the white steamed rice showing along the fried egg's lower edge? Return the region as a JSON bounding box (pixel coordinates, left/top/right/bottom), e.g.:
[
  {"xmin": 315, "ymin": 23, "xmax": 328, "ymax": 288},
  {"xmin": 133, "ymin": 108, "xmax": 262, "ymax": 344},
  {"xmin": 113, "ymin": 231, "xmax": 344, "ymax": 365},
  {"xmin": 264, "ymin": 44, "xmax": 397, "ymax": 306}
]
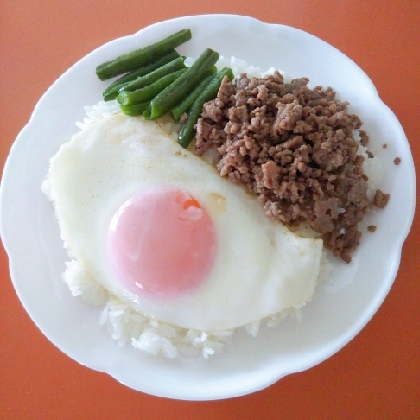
[{"xmin": 63, "ymin": 254, "xmax": 316, "ymax": 359}]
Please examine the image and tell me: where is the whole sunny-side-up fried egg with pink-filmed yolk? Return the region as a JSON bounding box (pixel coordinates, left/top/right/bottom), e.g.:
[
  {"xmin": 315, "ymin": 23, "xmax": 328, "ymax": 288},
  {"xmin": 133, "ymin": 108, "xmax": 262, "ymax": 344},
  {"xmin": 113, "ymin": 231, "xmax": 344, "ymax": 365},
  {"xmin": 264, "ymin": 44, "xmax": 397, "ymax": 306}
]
[{"xmin": 47, "ymin": 113, "xmax": 322, "ymax": 331}]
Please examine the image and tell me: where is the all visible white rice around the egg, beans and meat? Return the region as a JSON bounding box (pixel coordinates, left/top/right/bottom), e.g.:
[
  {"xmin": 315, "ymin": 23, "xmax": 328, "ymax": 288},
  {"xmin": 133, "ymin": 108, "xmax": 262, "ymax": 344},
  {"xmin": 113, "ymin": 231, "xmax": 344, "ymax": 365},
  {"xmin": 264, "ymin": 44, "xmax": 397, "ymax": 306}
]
[{"xmin": 52, "ymin": 56, "xmax": 380, "ymax": 359}]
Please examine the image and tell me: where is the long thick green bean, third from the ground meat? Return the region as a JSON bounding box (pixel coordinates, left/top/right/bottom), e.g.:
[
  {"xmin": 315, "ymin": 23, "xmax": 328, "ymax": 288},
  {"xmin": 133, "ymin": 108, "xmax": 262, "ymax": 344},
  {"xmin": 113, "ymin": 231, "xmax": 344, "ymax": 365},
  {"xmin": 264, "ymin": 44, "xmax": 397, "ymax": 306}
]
[{"xmin": 143, "ymin": 48, "xmax": 219, "ymax": 120}]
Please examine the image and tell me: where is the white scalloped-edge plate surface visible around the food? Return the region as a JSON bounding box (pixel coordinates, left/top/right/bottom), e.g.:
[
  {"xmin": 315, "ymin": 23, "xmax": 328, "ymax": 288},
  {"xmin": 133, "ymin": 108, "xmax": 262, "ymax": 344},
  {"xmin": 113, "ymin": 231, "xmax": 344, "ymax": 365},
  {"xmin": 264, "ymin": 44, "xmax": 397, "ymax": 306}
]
[{"xmin": 0, "ymin": 15, "xmax": 415, "ymax": 400}]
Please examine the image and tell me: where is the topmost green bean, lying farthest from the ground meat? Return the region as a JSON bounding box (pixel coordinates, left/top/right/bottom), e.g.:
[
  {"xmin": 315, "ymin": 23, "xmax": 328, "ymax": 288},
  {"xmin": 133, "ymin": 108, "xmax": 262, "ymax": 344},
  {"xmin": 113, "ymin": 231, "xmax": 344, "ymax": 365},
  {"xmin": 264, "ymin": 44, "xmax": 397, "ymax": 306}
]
[{"xmin": 96, "ymin": 29, "xmax": 191, "ymax": 80}]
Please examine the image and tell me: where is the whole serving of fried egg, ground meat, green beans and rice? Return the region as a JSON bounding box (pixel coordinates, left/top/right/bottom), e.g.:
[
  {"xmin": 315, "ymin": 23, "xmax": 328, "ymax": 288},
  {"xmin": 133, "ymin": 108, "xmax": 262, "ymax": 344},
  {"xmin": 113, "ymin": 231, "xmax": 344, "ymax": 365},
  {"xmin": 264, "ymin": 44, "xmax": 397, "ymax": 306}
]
[{"xmin": 43, "ymin": 29, "xmax": 389, "ymax": 358}]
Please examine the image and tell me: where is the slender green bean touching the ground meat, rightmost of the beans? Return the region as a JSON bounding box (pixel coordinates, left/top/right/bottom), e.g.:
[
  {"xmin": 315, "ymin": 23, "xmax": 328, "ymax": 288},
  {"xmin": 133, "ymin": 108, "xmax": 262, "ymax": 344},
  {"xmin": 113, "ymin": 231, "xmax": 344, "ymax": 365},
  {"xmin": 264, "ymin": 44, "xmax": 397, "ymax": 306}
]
[{"xmin": 178, "ymin": 67, "xmax": 233, "ymax": 149}]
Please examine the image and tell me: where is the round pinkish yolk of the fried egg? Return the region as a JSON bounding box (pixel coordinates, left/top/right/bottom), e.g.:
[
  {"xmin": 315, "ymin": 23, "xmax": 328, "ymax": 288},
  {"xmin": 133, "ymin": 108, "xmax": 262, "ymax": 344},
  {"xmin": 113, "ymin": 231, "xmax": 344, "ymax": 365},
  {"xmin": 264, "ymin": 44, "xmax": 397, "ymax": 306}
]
[{"xmin": 108, "ymin": 187, "xmax": 216, "ymax": 298}]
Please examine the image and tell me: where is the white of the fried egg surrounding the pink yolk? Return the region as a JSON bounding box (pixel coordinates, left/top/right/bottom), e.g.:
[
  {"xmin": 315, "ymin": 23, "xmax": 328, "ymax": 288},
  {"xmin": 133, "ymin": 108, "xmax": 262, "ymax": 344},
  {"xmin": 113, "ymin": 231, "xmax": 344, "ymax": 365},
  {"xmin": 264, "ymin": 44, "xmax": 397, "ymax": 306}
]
[{"xmin": 47, "ymin": 113, "xmax": 322, "ymax": 331}]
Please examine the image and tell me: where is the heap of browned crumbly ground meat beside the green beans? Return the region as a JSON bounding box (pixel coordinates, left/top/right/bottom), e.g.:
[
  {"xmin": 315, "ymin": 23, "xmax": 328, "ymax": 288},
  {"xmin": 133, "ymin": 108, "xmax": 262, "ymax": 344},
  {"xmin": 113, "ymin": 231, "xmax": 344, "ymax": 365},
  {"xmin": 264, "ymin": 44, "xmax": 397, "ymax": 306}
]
[{"xmin": 196, "ymin": 72, "xmax": 389, "ymax": 262}]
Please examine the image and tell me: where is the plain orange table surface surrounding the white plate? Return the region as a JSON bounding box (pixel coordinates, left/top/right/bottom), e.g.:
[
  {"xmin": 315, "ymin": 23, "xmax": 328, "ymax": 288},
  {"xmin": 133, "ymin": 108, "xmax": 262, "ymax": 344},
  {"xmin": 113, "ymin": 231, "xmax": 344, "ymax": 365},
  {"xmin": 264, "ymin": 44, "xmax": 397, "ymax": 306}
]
[{"xmin": 0, "ymin": 0, "xmax": 420, "ymax": 420}]
